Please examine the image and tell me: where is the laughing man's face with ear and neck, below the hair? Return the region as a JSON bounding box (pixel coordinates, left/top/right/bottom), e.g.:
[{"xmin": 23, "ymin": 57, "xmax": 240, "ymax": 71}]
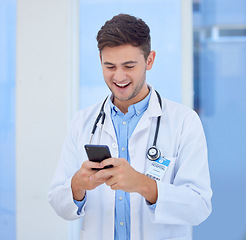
[{"xmin": 100, "ymin": 45, "xmax": 155, "ymax": 112}]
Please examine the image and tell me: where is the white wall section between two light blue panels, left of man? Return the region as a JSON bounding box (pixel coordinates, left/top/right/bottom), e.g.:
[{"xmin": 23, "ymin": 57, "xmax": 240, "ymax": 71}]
[{"xmin": 16, "ymin": 0, "xmax": 78, "ymax": 240}]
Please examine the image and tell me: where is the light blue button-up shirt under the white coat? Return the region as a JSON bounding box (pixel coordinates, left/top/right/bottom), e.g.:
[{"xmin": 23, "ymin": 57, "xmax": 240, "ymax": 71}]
[{"xmin": 74, "ymin": 89, "xmax": 151, "ymax": 240}]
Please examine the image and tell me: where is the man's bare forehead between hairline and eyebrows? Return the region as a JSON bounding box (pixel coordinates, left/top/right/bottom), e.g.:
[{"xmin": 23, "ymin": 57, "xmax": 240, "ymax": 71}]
[{"xmin": 101, "ymin": 45, "xmax": 144, "ymax": 64}]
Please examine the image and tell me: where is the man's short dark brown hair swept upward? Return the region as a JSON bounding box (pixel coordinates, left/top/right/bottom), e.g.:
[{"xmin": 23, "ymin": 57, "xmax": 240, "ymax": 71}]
[{"xmin": 97, "ymin": 14, "xmax": 151, "ymax": 59}]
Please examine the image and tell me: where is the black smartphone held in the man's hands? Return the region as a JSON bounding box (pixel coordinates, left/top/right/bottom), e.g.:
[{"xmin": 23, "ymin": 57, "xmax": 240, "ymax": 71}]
[{"xmin": 84, "ymin": 144, "xmax": 113, "ymax": 170}]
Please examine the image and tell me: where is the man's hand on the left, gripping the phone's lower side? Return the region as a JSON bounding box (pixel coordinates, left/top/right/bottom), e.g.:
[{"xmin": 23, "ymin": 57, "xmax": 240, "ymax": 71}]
[{"xmin": 71, "ymin": 161, "xmax": 107, "ymax": 201}]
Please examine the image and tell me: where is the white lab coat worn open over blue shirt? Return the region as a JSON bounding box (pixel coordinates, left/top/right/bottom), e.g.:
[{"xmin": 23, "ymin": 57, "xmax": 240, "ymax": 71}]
[{"xmin": 48, "ymin": 89, "xmax": 212, "ymax": 240}]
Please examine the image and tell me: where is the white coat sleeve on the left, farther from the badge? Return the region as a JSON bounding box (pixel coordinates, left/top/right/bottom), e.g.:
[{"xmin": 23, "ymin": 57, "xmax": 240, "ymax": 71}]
[{"xmin": 48, "ymin": 113, "xmax": 84, "ymax": 220}]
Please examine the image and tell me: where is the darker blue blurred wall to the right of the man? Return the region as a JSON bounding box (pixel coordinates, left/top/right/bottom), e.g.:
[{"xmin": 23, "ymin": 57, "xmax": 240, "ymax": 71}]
[{"xmin": 194, "ymin": 0, "xmax": 246, "ymax": 240}]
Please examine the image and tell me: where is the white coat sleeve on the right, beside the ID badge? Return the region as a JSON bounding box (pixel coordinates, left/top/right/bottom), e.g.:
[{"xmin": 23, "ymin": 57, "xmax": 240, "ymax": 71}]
[{"xmin": 149, "ymin": 111, "xmax": 212, "ymax": 226}]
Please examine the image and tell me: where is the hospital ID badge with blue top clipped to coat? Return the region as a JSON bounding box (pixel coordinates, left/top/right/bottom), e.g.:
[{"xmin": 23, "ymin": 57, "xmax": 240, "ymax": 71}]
[{"xmin": 145, "ymin": 157, "xmax": 170, "ymax": 181}]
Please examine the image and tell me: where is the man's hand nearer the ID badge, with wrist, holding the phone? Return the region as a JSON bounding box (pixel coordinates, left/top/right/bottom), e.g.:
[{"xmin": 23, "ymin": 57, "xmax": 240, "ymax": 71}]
[{"xmin": 90, "ymin": 158, "xmax": 157, "ymax": 203}]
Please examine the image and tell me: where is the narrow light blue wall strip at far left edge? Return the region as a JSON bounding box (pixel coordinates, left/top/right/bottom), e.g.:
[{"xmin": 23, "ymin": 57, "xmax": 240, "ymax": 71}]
[{"xmin": 0, "ymin": 0, "xmax": 16, "ymax": 240}]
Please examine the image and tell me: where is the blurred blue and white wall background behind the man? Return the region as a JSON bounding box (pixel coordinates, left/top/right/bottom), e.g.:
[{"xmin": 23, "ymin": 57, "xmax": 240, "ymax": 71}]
[{"xmin": 0, "ymin": 0, "xmax": 246, "ymax": 240}]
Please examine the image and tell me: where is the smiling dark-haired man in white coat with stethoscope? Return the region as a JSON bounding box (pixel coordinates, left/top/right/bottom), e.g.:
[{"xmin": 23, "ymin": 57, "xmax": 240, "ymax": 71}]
[{"xmin": 48, "ymin": 14, "xmax": 212, "ymax": 240}]
